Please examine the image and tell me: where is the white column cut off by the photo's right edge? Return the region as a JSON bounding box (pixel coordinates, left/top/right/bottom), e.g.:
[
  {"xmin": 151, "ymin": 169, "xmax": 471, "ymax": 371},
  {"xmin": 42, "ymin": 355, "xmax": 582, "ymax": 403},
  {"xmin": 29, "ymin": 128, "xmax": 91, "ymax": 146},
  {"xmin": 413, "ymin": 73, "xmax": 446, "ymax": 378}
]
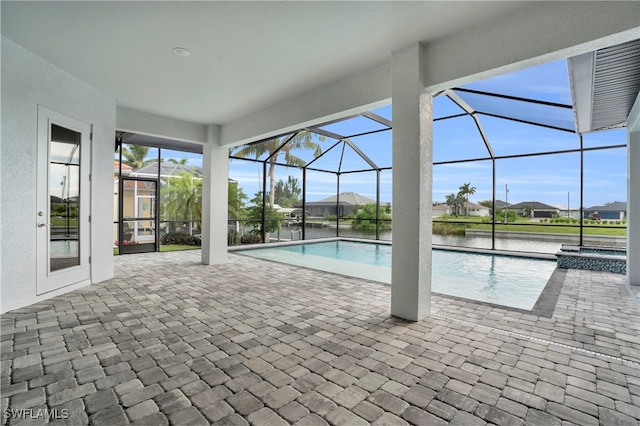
[{"xmin": 627, "ymin": 95, "xmax": 640, "ymax": 285}]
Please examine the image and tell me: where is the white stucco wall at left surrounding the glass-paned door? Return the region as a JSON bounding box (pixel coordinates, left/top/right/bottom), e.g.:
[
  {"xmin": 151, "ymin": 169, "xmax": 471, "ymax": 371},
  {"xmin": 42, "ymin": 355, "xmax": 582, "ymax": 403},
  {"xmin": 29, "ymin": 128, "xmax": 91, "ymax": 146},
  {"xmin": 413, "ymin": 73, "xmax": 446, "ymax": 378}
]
[{"xmin": 0, "ymin": 36, "xmax": 116, "ymax": 312}]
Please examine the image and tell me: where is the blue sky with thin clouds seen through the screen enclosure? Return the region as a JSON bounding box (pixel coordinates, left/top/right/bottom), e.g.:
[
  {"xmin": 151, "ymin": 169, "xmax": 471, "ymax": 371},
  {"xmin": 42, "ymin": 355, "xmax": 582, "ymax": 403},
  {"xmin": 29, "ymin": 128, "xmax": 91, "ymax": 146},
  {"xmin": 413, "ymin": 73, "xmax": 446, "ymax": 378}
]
[{"xmin": 127, "ymin": 60, "xmax": 626, "ymax": 209}]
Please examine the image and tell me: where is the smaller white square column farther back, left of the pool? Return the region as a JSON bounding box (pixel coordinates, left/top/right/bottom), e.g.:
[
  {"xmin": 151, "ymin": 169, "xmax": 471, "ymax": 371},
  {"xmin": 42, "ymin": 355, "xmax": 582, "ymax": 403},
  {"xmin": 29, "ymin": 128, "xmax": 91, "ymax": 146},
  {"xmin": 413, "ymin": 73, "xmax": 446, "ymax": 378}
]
[{"xmin": 202, "ymin": 125, "xmax": 229, "ymax": 265}]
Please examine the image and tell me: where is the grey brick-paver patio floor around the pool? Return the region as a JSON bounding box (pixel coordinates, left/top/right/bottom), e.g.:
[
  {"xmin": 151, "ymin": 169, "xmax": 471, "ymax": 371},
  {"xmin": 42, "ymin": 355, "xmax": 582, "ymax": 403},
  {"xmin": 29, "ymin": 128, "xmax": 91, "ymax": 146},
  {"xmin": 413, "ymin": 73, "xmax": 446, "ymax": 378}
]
[{"xmin": 0, "ymin": 250, "xmax": 640, "ymax": 426}]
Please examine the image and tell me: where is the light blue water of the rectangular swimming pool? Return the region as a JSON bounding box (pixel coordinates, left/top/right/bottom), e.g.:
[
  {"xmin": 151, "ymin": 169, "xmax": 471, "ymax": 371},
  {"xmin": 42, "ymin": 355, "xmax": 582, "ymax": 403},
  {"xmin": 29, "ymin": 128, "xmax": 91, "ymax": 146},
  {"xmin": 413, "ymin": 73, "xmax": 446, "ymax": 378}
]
[{"xmin": 236, "ymin": 240, "xmax": 556, "ymax": 310}]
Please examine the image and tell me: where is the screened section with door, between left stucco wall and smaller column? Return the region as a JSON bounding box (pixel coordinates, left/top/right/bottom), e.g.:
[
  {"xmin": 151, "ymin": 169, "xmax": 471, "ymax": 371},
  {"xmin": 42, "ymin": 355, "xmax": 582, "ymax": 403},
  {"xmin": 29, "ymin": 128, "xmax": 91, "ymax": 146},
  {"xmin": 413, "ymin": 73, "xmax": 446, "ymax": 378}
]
[{"xmin": 113, "ymin": 132, "xmax": 202, "ymax": 254}]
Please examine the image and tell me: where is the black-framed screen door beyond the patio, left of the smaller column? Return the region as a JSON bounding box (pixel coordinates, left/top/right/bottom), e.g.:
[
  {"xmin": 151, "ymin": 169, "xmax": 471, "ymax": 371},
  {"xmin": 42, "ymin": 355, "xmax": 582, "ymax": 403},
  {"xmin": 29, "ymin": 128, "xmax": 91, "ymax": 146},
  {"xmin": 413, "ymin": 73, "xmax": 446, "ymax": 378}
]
[{"xmin": 118, "ymin": 177, "xmax": 159, "ymax": 254}]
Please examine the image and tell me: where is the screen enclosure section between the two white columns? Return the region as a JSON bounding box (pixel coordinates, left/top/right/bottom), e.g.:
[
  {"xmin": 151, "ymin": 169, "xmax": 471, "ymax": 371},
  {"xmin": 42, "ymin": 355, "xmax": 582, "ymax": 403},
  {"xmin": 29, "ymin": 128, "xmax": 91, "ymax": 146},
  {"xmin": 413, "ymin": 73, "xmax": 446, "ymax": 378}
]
[{"xmin": 229, "ymin": 108, "xmax": 392, "ymax": 245}]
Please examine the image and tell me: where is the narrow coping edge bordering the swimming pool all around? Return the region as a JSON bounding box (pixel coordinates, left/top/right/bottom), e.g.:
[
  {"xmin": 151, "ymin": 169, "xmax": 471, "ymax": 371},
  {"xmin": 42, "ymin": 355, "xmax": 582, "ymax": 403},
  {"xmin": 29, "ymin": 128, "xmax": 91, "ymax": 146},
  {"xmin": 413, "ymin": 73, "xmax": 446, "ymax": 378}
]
[{"xmin": 229, "ymin": 237, "xmax": 567, "ymax": 318}]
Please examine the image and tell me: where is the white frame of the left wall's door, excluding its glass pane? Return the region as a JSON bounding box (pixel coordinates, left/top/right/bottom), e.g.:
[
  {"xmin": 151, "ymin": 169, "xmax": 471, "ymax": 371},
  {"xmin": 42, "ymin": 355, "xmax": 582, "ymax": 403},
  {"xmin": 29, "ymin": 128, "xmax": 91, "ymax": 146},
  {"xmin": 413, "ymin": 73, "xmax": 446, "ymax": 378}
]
[{"xmin": 33, "ymin": 105, "xmax": 91, "ymax": 295}]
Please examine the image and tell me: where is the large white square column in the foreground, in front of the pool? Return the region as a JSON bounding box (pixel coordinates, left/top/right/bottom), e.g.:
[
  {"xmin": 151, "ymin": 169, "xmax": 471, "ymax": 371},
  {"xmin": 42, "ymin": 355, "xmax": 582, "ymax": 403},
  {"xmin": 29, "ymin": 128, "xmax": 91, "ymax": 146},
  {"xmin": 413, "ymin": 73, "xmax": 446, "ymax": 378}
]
[{"xmin": 391, "ymin": 44, "xmax": 433, "ymax": 321}]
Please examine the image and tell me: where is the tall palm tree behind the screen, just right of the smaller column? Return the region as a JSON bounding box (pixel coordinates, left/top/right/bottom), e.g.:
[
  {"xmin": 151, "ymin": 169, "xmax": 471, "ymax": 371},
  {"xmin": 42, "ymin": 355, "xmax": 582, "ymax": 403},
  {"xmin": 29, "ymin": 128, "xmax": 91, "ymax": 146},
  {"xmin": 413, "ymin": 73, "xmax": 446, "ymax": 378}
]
[{"xmin": 233, "ymin": 130, "xmax": 324, "ymax": 207}]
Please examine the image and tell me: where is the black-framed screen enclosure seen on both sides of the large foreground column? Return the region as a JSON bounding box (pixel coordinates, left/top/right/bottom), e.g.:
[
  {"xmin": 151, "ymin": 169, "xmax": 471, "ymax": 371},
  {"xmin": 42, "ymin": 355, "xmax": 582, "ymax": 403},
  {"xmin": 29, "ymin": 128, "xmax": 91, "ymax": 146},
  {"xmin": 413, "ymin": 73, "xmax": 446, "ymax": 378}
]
[{"xmin": 229, "ymin": 51, "xmax": 638, "ymax": 253}]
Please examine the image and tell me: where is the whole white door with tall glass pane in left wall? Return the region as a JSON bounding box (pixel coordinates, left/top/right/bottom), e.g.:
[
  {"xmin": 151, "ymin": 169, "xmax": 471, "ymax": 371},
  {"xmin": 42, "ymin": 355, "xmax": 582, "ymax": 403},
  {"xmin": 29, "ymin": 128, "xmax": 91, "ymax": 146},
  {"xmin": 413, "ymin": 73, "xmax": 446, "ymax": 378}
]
[{"xmin": 36, "ymin": 107, "xmax": 91, "ymax": 294}]
